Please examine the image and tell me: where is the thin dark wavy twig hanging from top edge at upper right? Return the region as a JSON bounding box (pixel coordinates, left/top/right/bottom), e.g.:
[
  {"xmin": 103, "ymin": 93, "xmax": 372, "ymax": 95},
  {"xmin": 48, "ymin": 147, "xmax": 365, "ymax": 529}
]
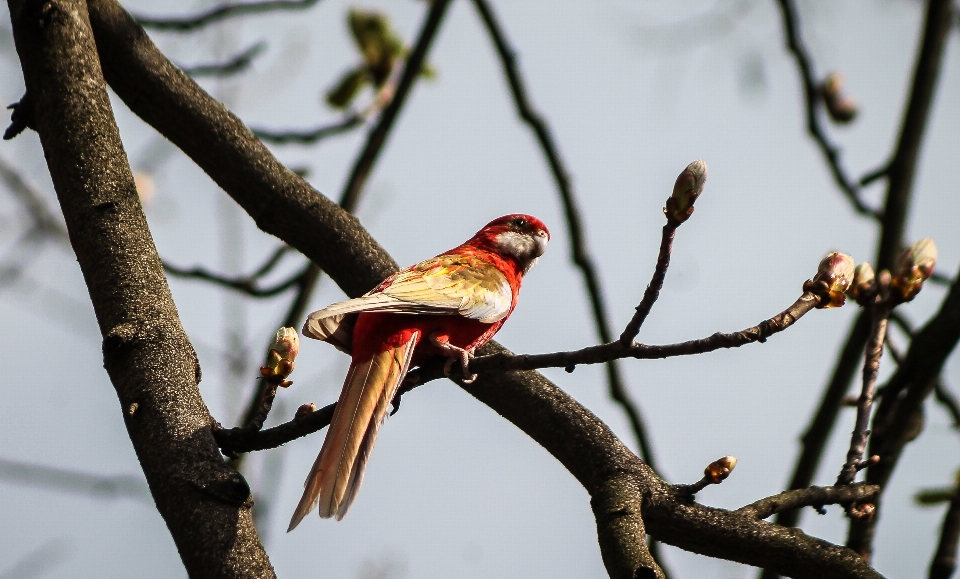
[{"xmin": 778, "ymin": 0, "xmax": 880, "ymax": 220}]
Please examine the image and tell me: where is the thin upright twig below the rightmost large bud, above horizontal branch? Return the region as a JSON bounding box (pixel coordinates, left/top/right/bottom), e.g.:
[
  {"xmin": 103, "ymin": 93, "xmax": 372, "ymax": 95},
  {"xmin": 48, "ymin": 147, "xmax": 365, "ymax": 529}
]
[{"xmin": 836, "ymin": 305, "xmax": 889, "ymax": 486}]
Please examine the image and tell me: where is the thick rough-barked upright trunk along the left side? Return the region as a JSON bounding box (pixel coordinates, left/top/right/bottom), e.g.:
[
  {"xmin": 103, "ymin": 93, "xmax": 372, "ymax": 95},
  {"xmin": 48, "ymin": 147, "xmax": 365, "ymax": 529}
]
[{"xmin": 9, "ymin": 0, "xmax": 274, "ymax": 578}]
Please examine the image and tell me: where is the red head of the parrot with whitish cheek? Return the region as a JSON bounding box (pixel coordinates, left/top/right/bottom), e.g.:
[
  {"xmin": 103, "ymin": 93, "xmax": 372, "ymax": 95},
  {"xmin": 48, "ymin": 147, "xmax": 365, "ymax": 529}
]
[{"xmin": 466, "ymin": 213, "xmax": 550, "ymax": 273}]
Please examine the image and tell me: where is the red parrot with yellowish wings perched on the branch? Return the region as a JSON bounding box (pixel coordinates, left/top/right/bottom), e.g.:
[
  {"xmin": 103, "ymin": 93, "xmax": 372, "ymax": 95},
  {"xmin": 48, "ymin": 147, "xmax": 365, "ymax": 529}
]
[{"xmin": 287, "ymin": 214, "xmax": 550, "ymax": 531}]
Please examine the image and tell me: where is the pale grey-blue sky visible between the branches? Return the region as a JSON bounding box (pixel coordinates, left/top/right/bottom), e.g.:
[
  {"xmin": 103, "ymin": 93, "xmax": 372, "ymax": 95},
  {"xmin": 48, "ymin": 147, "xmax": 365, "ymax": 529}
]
[{"xmin": 0, "ymin": 0, "xmax": 960, "ymax": 579}]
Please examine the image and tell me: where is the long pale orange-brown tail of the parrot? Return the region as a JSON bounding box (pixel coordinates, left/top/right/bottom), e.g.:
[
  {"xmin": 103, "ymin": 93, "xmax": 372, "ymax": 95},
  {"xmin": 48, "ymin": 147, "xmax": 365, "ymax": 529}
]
[{"xmin": 287, "ymin": 332, "xmax": 420, "ymax": 532}]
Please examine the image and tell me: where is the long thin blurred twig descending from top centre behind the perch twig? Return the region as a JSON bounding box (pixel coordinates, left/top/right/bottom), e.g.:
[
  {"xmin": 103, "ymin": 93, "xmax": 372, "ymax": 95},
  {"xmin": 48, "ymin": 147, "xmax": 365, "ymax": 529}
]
[{"xmin": 474, "ymin": 0, "xmax": 656, "ymax": 469}]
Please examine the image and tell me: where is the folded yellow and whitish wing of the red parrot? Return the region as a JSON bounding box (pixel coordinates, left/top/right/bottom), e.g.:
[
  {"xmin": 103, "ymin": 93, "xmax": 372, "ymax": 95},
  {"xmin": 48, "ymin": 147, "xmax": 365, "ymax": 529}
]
[{"xmin": 303, "ymin": 255, "xmax": 513, "ymax": 342}]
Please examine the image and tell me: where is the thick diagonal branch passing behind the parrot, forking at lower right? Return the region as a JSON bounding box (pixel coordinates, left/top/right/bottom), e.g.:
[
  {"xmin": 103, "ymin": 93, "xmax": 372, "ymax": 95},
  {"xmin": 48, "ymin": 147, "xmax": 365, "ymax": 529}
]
[{"xmin": 90, "ymin": 0, "xmax": 879, "ymax": 578}]
